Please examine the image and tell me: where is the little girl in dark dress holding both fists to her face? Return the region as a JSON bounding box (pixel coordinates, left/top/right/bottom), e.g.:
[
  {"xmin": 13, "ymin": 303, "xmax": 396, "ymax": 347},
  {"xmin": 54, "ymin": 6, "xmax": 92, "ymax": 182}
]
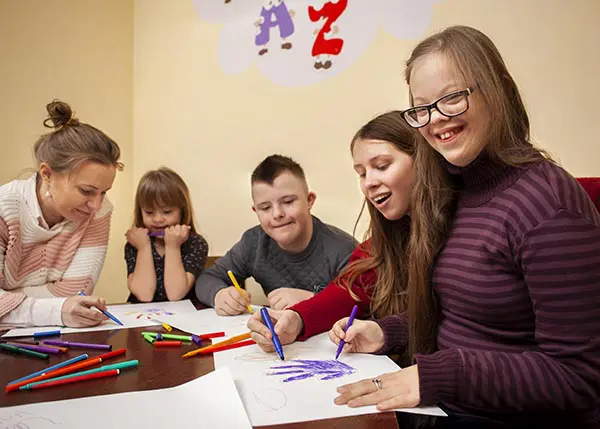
[{"xmin": 125, "ymin": 167, "xmax": 208, "ymax": 303}]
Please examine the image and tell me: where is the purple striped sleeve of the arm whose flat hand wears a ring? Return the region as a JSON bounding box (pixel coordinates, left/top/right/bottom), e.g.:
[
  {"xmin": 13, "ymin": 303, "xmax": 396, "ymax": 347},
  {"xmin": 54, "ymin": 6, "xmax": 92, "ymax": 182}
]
[{"xmin": 417, "ymin": 210, "xmax": 600, "ymax": 412}]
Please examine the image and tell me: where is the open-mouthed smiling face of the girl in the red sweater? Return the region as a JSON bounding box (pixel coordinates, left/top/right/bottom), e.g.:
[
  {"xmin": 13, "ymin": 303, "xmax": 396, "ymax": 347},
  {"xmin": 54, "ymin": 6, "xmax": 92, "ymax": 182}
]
[{"xmin": 352, "ymin": 140, "xmax": 415, "ymax": 221}]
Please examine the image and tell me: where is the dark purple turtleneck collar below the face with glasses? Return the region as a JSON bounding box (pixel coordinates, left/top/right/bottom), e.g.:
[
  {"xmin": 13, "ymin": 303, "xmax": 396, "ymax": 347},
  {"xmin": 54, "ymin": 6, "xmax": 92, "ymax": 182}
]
[{"xmin": 444, "ymin": 150, "xmax": 525, "ymax": 207}]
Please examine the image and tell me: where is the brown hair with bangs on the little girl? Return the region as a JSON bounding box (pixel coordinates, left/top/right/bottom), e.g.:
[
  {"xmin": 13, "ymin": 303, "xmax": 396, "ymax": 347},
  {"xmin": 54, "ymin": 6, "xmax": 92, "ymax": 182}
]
[{"xmin": 133, "ymin": 167, "xmax": 196, "ymax": 232}]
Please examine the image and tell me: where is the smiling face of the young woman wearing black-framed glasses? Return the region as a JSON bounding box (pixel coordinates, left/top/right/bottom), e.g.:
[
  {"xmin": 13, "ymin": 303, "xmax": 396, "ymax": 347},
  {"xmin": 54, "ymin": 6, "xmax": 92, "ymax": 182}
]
[{"xmin": 410, "ymin": 53, "xmax": 490, "ymax": 167}]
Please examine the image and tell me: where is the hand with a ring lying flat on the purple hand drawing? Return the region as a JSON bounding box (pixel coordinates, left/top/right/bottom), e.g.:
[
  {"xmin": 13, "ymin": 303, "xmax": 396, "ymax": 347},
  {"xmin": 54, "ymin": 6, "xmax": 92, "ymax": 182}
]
[{"xmin": 334, "ymin": 365, "xmax": 421, "ymax": 411}]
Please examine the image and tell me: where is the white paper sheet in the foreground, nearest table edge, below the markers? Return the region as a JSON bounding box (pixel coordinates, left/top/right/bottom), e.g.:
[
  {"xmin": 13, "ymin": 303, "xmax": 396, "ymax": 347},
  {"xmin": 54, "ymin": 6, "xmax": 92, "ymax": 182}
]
[{"xmin": 0, "ymin": 368, "xmax": 252, "ymax": 429}]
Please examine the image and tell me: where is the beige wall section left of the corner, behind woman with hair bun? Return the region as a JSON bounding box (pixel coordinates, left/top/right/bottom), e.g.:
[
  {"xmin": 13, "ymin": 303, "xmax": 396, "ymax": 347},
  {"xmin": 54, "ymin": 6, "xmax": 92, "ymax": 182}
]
[{"xmin": 0, "ymin": 0, "xmax": 133, "ymax": 302}]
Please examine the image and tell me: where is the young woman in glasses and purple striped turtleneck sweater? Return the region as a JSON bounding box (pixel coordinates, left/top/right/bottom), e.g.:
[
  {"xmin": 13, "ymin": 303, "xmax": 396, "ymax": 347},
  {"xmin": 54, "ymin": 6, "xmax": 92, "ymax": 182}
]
[{"xmin": 330, "ymin": 27, "xmax": 600, "ymax": 428}]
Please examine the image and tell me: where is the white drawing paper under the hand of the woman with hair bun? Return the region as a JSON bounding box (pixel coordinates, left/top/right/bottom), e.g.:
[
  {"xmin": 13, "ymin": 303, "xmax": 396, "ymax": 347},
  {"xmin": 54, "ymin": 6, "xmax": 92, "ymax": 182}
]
[{"xmin": 2, "ymin": 299, "xmax": 197, "ymax": 337}]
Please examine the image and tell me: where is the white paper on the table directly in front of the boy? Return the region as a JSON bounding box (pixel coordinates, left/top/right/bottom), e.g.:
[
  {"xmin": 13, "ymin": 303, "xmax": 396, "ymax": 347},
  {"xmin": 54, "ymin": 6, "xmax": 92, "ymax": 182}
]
[{"xmin": 160, "ymin": 305, "xmax": 261, "ymax": 341}]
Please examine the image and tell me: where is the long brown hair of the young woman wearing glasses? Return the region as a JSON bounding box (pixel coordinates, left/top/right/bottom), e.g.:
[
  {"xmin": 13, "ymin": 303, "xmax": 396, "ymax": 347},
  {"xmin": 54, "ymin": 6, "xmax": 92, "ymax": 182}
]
[{"xmin": 405, "ymin": 26, "xmax": 549, "ymax": 356}]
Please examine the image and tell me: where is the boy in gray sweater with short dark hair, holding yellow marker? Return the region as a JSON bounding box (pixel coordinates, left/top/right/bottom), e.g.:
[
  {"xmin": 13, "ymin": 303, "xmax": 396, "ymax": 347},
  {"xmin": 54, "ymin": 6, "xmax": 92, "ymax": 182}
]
[{"xmin": 196, "ymin": 155, "xmax": 357, "ymax": 315}]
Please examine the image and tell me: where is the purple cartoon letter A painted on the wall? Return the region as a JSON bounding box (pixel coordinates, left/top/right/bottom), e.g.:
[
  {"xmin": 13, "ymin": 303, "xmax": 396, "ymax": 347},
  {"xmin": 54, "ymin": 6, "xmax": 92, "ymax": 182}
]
[{"xmin": 254, "ymin": 0, "xmax": 295, "ymax": 55}]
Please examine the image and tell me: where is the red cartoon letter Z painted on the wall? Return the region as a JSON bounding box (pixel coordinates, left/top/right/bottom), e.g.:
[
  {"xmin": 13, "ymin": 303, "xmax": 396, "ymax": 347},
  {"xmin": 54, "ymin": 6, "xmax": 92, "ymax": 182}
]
[{"xmin": 308, "ymin": 0, "xmax": 348, "ymax": 70}]
